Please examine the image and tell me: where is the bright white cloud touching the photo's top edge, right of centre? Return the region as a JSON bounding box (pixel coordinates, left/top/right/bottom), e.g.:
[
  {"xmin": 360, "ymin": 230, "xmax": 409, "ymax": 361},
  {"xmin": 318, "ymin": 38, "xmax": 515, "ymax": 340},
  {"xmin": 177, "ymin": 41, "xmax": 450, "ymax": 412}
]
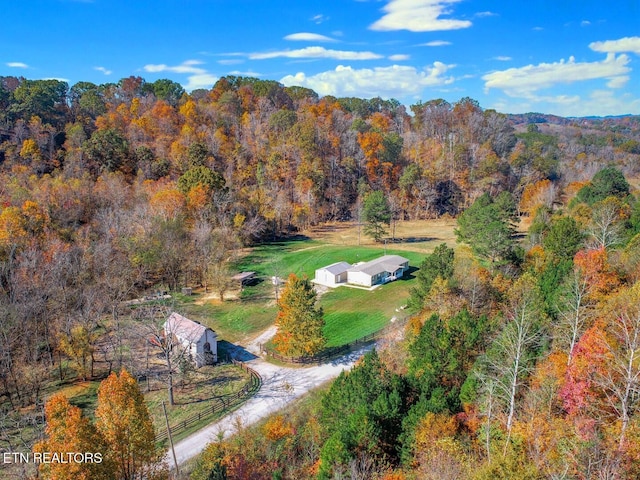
[{"xmin": 369, "ymin": 0, "xmax": 471, "ymax": 32}]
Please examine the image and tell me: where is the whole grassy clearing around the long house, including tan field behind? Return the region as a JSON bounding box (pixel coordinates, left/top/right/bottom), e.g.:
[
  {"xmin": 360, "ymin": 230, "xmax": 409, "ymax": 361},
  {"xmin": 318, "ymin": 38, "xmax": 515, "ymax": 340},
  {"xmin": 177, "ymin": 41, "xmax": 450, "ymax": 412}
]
[{"xmin": 180, "ymin": 219, "xmax": 456, "ymax": 346}]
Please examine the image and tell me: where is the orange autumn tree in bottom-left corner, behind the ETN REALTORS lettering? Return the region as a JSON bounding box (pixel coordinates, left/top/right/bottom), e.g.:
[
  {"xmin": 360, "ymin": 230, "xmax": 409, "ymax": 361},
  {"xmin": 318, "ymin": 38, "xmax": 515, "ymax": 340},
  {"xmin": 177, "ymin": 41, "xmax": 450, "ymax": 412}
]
[{"xmin": 33, "ymin": 393, "xmax": 112, "ymax": 480}]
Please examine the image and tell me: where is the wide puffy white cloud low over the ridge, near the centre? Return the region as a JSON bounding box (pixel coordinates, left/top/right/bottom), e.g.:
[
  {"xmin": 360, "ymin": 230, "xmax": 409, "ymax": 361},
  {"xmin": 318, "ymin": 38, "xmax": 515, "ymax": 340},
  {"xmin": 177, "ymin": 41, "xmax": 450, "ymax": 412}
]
[{"xmin": 280, "ymin": 62, "xmax": 455, "ymax": 98}]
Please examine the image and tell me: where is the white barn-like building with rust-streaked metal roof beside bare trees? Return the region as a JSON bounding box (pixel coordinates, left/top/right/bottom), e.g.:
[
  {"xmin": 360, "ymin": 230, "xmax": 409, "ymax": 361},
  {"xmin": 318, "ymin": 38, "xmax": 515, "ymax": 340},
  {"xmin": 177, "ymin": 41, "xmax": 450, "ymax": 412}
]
[{"xmin": 164, "ymin": 312, "xmax": 218, "ymax": 368}]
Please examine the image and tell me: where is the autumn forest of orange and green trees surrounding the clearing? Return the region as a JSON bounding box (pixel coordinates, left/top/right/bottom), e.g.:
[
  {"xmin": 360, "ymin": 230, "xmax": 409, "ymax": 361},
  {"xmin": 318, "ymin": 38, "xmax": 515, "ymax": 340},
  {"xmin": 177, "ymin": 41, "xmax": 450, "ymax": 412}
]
[{"xmin": 0, "ymin": 76, "xmax": 640, "ymax": 480}]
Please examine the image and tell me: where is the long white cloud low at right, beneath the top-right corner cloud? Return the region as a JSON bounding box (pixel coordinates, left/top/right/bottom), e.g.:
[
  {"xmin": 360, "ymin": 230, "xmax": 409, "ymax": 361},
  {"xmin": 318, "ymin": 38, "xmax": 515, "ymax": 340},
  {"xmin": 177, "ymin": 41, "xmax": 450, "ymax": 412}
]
[{"xmin": 482, "ymin": 53, "xmax": 631, "ymax": 98}]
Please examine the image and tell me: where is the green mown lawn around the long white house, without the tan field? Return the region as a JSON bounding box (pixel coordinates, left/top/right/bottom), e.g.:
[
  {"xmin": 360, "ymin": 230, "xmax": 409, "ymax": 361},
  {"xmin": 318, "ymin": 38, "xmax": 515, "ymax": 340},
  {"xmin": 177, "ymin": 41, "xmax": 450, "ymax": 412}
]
[{"xmin": 183, "ymin": 240, "xmax": 424, "ymax": 346}]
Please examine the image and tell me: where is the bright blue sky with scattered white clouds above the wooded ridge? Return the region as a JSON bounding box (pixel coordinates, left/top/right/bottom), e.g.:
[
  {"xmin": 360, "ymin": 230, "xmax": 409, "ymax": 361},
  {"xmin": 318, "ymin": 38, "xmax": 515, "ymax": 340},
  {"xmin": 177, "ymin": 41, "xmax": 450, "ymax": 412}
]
[{"xmin": 0, "ymin": 0, "xmax": 640, "ymax": 116}]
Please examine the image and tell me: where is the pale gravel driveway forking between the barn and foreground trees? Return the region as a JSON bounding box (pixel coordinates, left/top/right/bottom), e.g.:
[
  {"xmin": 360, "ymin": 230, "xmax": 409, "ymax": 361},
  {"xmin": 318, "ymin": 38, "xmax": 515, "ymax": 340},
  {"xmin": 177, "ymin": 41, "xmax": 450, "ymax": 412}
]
[{"xmin": 166, "ymin": 336, "xmax": 373, "ymax": 467}]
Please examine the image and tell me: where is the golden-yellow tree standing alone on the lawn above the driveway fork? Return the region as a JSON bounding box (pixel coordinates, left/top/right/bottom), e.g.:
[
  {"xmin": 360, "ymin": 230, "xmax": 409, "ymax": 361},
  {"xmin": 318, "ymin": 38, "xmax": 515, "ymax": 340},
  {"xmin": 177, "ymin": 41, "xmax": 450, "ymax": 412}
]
[{"xmin": 273, "ymin": 273, "xmax": 326, "ymax": 357}]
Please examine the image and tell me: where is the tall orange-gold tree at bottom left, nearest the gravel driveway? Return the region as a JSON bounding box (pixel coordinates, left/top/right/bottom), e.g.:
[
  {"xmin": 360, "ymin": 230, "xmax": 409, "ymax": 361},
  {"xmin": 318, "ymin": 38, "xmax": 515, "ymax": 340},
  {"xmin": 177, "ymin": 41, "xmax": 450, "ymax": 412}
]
[{"xmin": 96, "ymin": 369, "xmax": 164, "ymax": 480}]
